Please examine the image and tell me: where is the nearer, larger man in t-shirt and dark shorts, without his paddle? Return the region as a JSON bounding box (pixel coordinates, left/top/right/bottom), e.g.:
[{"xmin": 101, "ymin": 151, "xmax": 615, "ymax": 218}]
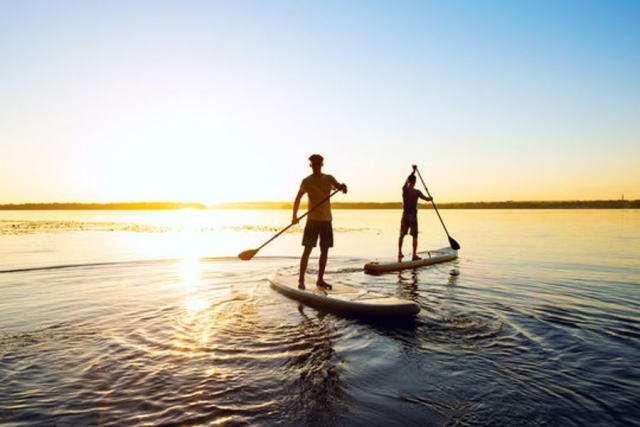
[{"xmin": 292, "ymin": 154, "xmax": 347, "ymax": 289}]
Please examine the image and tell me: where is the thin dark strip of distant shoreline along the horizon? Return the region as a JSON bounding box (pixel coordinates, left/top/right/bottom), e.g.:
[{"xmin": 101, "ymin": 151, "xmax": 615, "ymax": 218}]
[{"xmin": 0, "ymin": 200, "xmax": 640, "ymax": 211}]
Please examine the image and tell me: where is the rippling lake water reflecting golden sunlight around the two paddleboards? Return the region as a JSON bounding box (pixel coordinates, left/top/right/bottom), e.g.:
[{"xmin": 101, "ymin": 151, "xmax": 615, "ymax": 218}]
[{"xmin": 0, "ymin": 210, "xmax": 640, "ymax": 427}]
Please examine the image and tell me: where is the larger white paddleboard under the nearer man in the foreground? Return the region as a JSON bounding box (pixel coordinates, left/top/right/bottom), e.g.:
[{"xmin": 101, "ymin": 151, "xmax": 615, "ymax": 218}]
[{"xmin": 268, "ymin": 273, "xmax": 420, "ymax": 317}]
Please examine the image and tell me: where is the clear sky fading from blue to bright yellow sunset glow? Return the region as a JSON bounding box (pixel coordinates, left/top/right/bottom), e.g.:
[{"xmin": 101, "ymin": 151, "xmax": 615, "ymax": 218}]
[{"xmin": 0, "ymin": 0, "xmax": 640, "ymax": 204}]
